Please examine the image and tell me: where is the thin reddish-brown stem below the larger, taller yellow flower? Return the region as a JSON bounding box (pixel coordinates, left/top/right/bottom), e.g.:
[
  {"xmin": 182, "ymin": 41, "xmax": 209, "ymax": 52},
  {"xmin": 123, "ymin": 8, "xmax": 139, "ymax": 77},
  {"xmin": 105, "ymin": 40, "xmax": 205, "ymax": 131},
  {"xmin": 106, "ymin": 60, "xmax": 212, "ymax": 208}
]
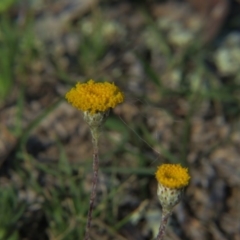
[{"xmin": 84, "ymin": 132, "xmax": 99, "ymax": 240}]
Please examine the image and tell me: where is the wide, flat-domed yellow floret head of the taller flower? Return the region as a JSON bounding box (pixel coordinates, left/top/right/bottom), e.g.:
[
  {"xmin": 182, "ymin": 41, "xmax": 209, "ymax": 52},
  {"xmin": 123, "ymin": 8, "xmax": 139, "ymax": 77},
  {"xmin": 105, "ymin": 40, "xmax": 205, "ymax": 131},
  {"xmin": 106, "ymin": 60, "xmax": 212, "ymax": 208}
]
[{"xmin": 65, "ymin": 80, "xmax": 124, "ymax": 114}]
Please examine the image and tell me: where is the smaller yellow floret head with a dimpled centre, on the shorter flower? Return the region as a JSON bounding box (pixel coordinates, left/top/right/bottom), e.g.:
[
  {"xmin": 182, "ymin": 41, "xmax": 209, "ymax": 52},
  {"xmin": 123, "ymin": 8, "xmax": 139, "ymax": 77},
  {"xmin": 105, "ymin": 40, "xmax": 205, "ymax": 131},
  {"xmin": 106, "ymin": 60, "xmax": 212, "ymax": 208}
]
[{"xmin": 156, "ymin": 164, "xmax": 190, "ymax": 189}]
